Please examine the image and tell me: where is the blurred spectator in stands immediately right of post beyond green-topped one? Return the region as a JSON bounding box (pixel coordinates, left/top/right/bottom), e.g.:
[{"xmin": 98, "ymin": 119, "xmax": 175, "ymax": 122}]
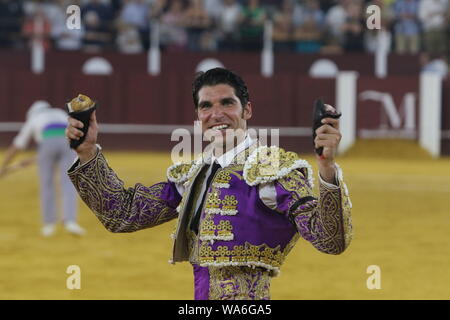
[{"xmin": 272, "ymin": 0, "xmax": 295, "ymax": 51}]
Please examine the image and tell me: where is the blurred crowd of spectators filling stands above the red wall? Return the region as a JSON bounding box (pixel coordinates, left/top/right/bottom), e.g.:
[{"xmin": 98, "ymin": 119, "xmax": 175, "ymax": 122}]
[{"xmin": 0, "ymin": 0, "xmax": 450, "ymax": 56}]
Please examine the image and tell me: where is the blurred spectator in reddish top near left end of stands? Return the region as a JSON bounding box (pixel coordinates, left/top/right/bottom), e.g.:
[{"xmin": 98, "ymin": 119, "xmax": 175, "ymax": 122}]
[{"xmin": 22, "ymin": 5, "xmax": 51, "ymax": 51}]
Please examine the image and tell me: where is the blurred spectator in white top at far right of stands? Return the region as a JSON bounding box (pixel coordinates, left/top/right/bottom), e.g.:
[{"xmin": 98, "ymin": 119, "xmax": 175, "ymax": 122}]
[{"xmin": 419, "ymin": 0, "xmax": 448, "ymax": 54}]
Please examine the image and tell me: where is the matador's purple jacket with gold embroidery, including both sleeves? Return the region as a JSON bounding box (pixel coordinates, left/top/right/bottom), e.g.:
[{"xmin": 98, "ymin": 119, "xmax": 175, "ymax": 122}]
[{"xmin": 69, "ymin": 143, "xmax": 352, "ymax": 275}]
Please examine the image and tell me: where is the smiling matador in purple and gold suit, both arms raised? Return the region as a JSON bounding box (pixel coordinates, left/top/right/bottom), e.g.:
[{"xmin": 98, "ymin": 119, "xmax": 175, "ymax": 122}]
[{"xmin": 66, "ymin": 68, "xmax": 352, "ymax": 300}]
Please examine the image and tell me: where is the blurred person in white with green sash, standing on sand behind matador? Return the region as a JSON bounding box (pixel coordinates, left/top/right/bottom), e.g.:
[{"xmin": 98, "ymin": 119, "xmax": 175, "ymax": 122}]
[{"xmin": 0, "ymin": 100, "xmax": 85, "ymax": 237}]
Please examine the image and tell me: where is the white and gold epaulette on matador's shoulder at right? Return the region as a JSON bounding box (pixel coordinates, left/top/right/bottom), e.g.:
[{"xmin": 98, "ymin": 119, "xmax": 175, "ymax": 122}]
[{"xmin": 243, "ymin": 146, "xmax": 313, "ymax": 187}]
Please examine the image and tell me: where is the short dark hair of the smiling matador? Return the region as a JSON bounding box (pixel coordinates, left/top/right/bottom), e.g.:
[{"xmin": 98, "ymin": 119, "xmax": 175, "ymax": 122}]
[{"xmin": 192, "ymin": 68, "xmax": 250, "ymax": 109}]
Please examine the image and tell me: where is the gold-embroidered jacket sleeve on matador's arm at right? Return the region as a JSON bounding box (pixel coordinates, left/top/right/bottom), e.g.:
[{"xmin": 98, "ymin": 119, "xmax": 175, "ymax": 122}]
[{"xmin": 266, "ymin": 167, "xmax": 352, "ymax": 254}]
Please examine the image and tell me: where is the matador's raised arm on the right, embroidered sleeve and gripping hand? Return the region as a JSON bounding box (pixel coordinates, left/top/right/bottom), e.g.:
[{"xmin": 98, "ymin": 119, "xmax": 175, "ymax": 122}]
[{"xmin": 292, "ymin": 105, "xmax": 352, "ymax": 254}]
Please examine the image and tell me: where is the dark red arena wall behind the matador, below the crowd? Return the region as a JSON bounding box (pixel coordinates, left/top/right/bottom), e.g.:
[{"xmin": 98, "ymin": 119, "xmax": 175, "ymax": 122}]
[{"xmin": 0, "ymin": 52, "xmax": 450, "ymax": 155}]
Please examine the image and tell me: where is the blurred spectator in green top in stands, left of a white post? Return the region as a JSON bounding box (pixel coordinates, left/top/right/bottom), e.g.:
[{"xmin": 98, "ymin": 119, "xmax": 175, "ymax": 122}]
[{"xmin": 240, "ymin": 0, "xmax": 266, "ymax": 51}]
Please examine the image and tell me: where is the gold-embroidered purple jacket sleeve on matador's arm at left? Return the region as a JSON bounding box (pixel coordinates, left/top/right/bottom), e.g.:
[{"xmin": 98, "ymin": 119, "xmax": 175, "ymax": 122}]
[{"xmin": 68, "ymin": 150, "xmax": 181, "ymax": 232}]
